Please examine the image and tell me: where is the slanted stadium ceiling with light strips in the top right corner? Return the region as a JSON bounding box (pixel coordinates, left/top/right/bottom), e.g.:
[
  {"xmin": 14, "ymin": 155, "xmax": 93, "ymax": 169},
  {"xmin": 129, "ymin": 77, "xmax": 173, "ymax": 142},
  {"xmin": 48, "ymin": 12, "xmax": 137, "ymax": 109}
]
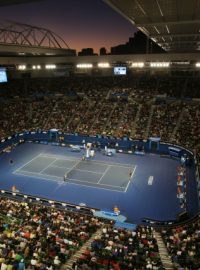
[{"xmin": 103, "ymin": 0, "xmax": 200, "ymax": 52}]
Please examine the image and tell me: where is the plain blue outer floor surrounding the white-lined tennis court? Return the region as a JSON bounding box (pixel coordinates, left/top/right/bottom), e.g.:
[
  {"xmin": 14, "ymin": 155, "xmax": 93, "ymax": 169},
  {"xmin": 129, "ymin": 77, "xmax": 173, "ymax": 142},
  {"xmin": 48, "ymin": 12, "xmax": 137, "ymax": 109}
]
[{"xmin": 0, "ymin": 143, "xmax": 198, "ymax": 223}]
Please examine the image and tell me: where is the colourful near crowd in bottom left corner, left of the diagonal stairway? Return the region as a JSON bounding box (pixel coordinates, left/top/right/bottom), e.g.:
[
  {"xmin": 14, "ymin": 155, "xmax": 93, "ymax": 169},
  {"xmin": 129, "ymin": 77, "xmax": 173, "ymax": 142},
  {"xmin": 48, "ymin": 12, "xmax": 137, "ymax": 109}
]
[{"xmin": 0, "ymin": 198, "xmax": 101, "ymax": 270}]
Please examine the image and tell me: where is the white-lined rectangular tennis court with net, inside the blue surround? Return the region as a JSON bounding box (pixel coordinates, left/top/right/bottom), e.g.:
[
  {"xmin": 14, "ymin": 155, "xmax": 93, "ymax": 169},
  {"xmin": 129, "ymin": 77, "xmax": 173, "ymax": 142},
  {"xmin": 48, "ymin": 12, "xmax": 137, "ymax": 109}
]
[{"xmin": 13, "ymin": 154, "xmax": 136, "ymax": 192}]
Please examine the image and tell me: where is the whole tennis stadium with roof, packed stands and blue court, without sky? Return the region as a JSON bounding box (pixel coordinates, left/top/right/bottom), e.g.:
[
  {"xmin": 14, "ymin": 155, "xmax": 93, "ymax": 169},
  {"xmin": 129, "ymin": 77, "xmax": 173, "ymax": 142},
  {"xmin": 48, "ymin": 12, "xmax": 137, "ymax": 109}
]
[{"xmin": 0, "ymin": 0, "xmax": 200, "ymax": 270}]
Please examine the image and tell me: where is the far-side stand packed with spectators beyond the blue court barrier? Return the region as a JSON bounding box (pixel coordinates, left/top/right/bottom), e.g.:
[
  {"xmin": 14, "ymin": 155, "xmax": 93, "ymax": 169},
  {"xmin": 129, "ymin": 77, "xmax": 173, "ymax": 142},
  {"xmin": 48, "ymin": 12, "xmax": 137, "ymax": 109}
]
[{"xmin": 0, "ymin": 75, "xmax": 200, "ymax": 156}]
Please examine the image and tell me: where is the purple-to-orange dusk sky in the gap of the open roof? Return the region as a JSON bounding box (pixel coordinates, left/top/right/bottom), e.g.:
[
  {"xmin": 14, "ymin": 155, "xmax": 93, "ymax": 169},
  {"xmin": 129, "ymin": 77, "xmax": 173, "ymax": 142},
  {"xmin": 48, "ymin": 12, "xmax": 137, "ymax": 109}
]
[{"xmin": 0, "ymin": 0, "xmax": 136, "ymax": 53}]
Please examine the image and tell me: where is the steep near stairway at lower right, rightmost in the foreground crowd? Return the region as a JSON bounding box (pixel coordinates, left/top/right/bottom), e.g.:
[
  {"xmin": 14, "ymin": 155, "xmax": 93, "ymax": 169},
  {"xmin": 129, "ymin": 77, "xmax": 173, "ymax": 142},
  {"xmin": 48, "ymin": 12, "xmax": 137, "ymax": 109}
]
[{"xmin": 154, "ymin": 232, "xmax": 174, "ymax": 270}]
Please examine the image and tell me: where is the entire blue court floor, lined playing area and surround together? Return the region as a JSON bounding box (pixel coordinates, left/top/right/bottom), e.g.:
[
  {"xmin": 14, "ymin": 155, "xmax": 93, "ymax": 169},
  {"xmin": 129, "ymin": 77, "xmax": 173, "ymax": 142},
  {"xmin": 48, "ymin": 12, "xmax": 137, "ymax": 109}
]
[{"xmin": 0, "ymin": 142, "xmax": 195, "ymax": 223}]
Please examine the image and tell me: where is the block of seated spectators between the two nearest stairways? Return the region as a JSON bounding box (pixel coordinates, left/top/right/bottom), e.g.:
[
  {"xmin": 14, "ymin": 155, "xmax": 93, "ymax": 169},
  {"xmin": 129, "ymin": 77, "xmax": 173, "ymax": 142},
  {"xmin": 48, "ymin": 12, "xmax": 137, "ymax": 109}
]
[{"xmin": 74, "ymin": 225, "xmax": 163, "ymax": 270}]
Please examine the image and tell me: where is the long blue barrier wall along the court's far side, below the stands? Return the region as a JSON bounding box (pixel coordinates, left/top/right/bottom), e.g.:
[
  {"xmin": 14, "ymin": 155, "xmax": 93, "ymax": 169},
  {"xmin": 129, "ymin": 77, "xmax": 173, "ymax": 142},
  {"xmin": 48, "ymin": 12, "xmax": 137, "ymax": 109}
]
[{"xmin": 0, "ymin": 130, "xmax": 194, "ymax": 160}]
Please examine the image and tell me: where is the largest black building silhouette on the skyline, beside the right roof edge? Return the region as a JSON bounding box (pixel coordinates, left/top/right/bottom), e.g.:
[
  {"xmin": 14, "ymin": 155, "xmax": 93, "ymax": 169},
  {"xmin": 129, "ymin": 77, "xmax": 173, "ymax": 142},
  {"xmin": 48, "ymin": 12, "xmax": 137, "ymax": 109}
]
[{"xmin": 111, "ymin": 31, "xmax": 165, "ymax": 54}]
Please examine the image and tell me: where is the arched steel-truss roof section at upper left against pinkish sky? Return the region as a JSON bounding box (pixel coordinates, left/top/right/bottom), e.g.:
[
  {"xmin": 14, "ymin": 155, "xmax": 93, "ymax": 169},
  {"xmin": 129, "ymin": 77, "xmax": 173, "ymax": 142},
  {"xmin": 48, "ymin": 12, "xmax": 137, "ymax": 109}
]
[{"xmin": 0, "ymin": 21, "xmax": 76, "ymax": 55}]
